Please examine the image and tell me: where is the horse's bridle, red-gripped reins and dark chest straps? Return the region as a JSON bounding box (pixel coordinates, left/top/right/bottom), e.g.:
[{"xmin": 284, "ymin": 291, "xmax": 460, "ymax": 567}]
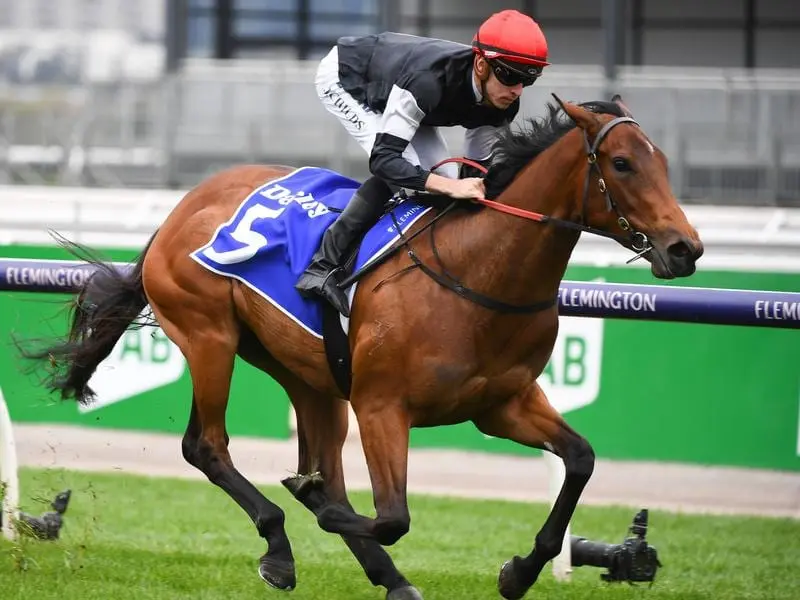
[{"xmin": 338, "ymin": 117, "xmax": 653, "ymax": 314}]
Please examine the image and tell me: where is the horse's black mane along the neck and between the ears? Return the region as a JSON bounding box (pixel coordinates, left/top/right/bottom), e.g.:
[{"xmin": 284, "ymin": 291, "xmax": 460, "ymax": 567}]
[{"xmin": 484, "ymin": 100, "xmax": 624, "ymax": 199}]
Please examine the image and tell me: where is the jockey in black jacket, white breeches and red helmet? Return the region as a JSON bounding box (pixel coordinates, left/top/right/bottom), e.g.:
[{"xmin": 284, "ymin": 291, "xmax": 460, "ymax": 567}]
[{"xmin": 295, "ymin": 10, "xmax": 549, "ymax": 317}]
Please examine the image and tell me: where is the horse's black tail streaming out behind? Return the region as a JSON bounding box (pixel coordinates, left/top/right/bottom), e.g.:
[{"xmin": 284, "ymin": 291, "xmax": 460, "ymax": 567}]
[{"xmin": 17, "ymin": 234, "xmax": 155, "ymax": 404}]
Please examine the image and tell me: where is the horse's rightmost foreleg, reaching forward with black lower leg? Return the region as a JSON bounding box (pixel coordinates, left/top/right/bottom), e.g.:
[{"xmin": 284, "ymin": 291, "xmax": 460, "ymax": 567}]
[{"xmin": 475, "ymin": 383, "xmax": 594, "ymax": 600}]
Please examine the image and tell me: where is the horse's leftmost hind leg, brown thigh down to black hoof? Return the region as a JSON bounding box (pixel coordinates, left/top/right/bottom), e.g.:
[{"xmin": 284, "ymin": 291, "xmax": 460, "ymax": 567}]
[{"xmin": 154, "ymin": 310, "xmax": 296, "ymax": 590}]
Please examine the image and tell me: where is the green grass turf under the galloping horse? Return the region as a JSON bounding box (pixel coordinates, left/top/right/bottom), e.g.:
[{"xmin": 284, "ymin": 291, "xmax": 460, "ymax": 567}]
[{"xmin": 0, "ymin": 469, "xmax": 800, "ymax": 600}]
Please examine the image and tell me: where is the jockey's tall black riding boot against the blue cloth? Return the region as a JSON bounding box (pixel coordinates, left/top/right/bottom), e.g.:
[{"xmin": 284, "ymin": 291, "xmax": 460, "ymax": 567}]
[{"xmin": 295, "ymin": 177, "xmax": 392, "ymax": 317}]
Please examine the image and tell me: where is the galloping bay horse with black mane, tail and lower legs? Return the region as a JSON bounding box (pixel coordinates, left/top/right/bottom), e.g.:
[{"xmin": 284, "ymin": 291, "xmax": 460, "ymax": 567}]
[{"xmin": 27, "ymin": 95, "xmax": 703, "ymax": 600}]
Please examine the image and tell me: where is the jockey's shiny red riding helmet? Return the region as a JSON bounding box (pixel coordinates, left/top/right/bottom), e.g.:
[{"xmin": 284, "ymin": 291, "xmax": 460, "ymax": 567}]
[{"xmin": 472, "ymin": 10, "xmax": 550, "ymax": 67}]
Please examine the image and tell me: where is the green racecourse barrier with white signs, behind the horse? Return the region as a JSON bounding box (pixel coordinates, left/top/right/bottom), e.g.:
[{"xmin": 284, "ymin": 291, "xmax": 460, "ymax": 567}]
[{"xmin": 0, "ymin": 246, "xmax": 800, "ymax": 471}]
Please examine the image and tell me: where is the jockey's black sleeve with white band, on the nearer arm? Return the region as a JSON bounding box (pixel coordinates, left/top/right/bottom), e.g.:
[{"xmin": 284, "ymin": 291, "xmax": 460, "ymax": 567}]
[{"xmin": 369, "ymin": 77, "xmax": 441, "ymax": 191}]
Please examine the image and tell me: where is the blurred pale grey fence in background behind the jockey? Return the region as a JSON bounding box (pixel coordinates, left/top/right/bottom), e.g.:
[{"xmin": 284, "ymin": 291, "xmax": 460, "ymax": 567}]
[{"xmin": 0, "ymin": 59, "xmax": 800, "ymax": 206}]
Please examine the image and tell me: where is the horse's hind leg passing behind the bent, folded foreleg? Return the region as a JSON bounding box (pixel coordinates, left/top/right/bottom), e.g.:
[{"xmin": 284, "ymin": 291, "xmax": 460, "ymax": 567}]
[{"xmin": 281, "ymin": 379, "xmax": 422, "ymax": 600}]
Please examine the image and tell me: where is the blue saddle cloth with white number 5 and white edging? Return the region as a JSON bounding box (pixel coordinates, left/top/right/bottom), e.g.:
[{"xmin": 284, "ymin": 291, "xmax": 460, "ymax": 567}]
[{"xmin": 191, "ymin": 167, "xmax": 430, "ymax": 338}]
